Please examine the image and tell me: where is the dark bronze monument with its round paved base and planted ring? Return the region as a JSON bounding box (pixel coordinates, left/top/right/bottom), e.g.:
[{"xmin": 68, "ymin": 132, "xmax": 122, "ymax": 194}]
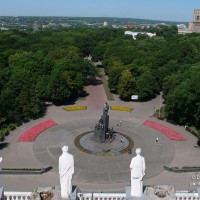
[{"xmin": 74, "ymin": 103, "xmax": 133, "ymax": 156}]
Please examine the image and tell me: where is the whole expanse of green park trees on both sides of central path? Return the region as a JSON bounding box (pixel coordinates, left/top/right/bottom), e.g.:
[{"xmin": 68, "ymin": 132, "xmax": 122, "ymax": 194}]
[{"xmin": 0, "ymin": 26, "xmax": 200, "ymax": 136}]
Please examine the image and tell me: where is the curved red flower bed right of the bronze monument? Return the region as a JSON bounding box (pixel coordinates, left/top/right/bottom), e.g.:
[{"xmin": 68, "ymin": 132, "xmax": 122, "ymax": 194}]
[{"xmin": 144, "ymin": 120, "xmax": 186, "ymax": 140}]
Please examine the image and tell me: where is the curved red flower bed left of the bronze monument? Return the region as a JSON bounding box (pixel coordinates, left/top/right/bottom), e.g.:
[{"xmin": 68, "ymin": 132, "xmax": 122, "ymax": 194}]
[{"xmin": 18, "ymin": 120, "xmax": 57, "ymax": 142}]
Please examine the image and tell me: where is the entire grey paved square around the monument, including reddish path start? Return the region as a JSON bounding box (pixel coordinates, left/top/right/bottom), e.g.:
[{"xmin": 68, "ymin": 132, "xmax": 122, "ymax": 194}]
[{"xmin": 0, "ymin": 81, "xmax": 200, "ymax": 192}]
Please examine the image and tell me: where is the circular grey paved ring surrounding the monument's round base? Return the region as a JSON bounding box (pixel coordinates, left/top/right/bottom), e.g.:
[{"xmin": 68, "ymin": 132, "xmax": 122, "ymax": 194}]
[{"xmin": 33, "ymin": 119, "xmax": 174, "ymax": 190}]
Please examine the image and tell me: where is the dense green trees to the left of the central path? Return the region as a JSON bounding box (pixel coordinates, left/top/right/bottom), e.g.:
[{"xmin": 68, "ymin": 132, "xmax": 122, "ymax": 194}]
[{"xmin": 0, "ymin": 27, "xmax": 98, "ymax": 135}]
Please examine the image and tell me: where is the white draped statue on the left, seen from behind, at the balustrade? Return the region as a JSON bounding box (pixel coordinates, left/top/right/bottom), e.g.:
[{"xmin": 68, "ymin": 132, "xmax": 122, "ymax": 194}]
[{"xmin": 59, "ymin": 146, "xmax": 74, "ymax": 199}]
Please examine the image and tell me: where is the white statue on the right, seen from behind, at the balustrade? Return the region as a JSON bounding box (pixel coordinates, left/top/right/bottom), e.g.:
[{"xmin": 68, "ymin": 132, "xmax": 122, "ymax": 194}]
[{"xmin": 130, "ymin": 148, "xmax": 146, "ymax": 197}]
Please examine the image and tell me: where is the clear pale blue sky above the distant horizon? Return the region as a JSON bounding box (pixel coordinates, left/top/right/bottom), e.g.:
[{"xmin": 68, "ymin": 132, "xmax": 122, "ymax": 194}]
[{"xmin": 0, "ymin": 0, "xmax": 200, "ymax": 22}]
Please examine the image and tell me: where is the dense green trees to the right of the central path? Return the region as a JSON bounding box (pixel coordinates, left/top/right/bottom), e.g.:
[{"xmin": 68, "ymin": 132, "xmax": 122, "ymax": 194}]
[{"xmin": 82, "ymin": 26, "xmax": 200, "ymax": 129}]
